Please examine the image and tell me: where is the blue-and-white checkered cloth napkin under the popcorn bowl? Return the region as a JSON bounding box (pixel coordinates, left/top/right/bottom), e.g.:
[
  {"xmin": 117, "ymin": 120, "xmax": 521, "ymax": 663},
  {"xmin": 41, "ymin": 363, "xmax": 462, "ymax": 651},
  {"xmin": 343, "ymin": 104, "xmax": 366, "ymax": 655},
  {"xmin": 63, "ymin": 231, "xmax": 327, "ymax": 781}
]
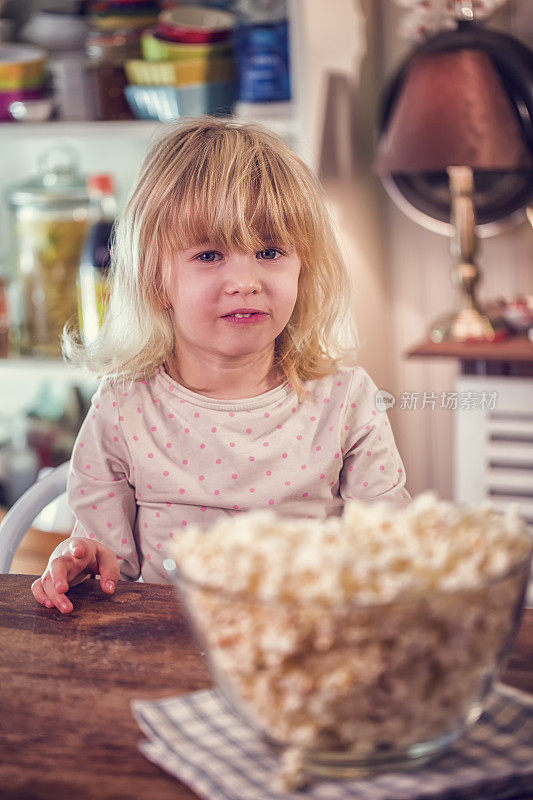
[{"xmin": 132, "ymin": 684, "xmax": 533, "ymax": 800}]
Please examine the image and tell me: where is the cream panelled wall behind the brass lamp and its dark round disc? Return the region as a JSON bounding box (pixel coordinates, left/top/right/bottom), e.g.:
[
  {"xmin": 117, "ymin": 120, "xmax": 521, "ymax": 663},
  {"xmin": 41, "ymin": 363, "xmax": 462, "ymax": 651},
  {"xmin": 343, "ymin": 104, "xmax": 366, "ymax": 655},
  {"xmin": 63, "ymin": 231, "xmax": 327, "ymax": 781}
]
[{"xmin": 376, "ymin": 0, "xmax": 533, "ymax": 498}]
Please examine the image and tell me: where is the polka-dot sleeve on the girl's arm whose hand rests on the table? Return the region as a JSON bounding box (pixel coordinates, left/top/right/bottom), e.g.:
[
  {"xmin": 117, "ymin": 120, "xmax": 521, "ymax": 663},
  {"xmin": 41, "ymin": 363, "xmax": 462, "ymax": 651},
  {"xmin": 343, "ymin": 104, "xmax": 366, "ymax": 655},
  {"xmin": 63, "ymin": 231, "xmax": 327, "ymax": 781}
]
[{"xmin": 67, "ymin": 386, "xmax": 140, "ymax": 579}]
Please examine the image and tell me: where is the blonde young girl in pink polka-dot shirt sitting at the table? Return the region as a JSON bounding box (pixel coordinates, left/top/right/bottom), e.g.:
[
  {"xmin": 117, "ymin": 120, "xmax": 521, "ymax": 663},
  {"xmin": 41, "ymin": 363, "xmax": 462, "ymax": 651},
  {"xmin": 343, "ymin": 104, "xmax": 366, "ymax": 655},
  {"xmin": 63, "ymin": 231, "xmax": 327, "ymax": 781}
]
[{"xmin": 32, "ymin": 117, "xmax": 410, "ymax": 612}]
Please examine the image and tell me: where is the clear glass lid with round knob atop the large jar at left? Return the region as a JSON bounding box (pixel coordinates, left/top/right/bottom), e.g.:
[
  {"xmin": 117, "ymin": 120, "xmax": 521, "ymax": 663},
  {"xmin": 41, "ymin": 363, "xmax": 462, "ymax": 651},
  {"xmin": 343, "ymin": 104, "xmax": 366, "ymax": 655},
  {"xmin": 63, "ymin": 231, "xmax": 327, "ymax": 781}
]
[{"xmin": 6, "ymin": 145, "xmax": 89, "ymax": 207}]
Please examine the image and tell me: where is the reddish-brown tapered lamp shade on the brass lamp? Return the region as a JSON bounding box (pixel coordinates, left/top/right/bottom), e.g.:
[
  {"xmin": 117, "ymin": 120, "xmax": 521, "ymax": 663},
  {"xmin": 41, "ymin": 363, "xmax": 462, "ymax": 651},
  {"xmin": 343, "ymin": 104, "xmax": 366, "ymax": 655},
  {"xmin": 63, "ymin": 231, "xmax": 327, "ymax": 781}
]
[{"xmin": 376, "ymin": 49, "xmax": 533, "ymax": 175}]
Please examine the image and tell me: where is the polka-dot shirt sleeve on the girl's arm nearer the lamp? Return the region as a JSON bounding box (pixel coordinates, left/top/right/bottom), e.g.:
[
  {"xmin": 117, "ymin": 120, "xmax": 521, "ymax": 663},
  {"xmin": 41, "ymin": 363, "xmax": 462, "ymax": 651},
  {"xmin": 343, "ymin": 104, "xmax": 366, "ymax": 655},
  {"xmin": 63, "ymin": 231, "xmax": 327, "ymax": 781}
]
[{"xmin": 340, "ymin": 367, "xmax": 411, "ymax": 506}]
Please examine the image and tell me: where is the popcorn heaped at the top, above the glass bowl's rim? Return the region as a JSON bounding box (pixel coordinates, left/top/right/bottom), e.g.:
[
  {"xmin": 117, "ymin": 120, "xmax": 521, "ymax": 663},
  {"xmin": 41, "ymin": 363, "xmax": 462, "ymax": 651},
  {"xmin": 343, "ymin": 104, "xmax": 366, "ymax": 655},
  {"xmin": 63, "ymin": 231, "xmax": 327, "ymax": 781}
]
[{"xmin": 174, "ymin": 492, "xmax": 529, "ymax": 604}]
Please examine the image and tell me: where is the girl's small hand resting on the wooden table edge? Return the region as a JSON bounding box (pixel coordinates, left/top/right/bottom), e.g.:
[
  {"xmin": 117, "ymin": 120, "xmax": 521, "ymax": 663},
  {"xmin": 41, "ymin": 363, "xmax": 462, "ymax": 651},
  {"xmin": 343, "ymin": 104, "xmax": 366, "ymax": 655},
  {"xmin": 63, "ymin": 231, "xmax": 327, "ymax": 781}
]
[{"xmin": 31, "ymin": 537, "xmax": 120, "ymax": 614}]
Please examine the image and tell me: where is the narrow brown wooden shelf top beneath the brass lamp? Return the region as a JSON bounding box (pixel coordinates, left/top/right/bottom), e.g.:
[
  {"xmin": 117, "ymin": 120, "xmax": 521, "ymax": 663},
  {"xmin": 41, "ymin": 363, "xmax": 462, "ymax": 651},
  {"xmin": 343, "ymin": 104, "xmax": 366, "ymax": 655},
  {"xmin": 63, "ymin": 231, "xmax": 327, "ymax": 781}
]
[{"xmin": 405, "ymin": 335, "xmax": 533, "ymax": 362}]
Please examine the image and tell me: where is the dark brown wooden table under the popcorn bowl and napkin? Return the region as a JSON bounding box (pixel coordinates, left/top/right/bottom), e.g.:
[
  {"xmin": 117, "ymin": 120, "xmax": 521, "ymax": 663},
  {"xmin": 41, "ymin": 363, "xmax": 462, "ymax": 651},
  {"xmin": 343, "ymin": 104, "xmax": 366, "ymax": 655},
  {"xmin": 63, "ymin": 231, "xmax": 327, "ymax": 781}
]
[{"xmin": 0, "ymin": 575, "xmax": 533, "ymax": 800}]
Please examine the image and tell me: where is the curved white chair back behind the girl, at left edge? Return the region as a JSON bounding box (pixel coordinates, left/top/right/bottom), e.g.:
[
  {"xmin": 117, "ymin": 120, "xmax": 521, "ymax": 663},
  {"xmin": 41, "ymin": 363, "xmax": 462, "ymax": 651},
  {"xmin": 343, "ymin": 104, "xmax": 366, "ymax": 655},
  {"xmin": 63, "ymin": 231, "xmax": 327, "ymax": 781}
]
[{"xmin": 0, "ymin": 461, "xmax": 70, "ymax": 574}]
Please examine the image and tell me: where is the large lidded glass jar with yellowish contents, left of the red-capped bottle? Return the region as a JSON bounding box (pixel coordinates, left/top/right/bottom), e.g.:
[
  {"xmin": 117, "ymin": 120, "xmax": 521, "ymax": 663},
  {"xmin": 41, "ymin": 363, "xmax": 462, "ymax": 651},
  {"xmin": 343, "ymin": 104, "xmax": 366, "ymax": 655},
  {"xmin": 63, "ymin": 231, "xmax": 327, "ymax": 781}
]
[{"xmin": 7, "ymin": 146, "xmax": 89, "ymax": 356}]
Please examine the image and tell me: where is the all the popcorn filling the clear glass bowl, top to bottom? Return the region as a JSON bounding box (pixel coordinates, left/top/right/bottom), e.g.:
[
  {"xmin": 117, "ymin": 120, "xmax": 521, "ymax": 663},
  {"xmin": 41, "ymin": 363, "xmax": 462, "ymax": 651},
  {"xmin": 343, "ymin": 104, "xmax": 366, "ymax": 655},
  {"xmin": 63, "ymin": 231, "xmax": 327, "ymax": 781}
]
[{"xmin": 172, "ymin": 492, "xmax": 531, "ymax": 786}]
